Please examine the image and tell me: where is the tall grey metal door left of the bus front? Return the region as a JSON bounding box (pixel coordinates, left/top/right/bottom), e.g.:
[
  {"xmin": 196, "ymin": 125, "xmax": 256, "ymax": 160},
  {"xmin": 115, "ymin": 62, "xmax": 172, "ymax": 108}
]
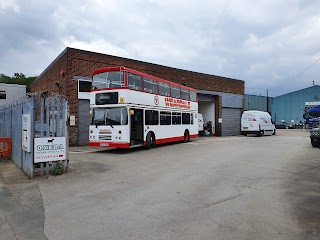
[{"xmin": 78, "ymin": 99, "xmax": 91, "ymax": 145}]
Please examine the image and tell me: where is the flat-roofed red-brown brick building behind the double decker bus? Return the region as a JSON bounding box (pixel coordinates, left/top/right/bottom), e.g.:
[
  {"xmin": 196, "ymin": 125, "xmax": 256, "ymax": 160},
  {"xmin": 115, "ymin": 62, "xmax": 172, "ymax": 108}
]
[{"xmin": 31, "ymin": 48, "xmax": 244, "ymax": 145}]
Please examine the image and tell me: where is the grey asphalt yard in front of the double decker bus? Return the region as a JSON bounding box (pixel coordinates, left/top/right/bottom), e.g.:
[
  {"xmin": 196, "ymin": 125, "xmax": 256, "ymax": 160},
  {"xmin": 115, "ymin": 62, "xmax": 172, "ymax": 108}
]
[{"xmin": 0, "ymin": 129, "xmax": 320, "ymax": 240}]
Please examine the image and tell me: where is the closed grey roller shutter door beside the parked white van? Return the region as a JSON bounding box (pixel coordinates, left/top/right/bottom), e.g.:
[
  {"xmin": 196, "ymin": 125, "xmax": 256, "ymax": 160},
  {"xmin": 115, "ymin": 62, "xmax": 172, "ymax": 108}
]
[{"xmin": 222, "ymin": 108, "xmax": 242, "ymax": 136}]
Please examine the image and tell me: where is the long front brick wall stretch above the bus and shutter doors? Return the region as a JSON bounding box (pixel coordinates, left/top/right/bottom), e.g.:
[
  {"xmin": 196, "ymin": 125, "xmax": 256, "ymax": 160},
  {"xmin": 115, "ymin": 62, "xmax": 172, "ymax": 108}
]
[{"xmin": 68, "ymin": 49, "xmax": 244, "ymax": 95}]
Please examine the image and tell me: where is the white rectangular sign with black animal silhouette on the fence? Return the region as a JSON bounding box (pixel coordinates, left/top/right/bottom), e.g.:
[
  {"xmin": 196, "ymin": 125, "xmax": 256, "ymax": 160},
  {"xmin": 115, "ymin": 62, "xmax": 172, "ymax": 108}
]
[{"xmin": 34, "ymin": 137, "xmax": 67, "ymax": 163}]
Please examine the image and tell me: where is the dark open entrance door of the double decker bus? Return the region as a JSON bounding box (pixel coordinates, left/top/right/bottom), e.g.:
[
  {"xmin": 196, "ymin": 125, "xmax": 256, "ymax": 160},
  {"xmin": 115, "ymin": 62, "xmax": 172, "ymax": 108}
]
[{"xmin": 130, "ymin": 108, "xmax": 143, "ymax": 145}]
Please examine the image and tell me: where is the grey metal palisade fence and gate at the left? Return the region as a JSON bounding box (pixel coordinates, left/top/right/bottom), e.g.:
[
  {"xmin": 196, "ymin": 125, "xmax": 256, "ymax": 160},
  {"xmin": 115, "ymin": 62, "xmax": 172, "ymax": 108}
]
[{"xmin": 0, "ymin": 93, "xmax": 69, "ymax": 178}]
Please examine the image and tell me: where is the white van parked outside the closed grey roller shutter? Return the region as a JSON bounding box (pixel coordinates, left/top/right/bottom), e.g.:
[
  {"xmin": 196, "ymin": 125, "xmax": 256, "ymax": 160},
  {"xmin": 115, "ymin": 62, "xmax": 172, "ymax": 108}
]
[{"xmin": 241, "ymin": 110, "xmax": 276, "ymax": 136}]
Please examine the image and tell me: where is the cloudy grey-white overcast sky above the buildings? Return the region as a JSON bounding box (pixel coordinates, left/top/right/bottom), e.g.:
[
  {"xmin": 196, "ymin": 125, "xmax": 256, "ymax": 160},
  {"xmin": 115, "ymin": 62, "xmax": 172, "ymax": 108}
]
[{"xmin": 0, "ymin": 0, "xmax": 320, "ymax": 96}]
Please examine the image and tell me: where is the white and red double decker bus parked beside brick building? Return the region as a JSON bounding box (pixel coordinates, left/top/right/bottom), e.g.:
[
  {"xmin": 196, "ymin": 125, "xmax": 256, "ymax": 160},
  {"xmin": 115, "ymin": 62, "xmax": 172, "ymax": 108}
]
[{"xmin": 89, "ymin": 67, "xmax": 198, "ymax": 149}]
